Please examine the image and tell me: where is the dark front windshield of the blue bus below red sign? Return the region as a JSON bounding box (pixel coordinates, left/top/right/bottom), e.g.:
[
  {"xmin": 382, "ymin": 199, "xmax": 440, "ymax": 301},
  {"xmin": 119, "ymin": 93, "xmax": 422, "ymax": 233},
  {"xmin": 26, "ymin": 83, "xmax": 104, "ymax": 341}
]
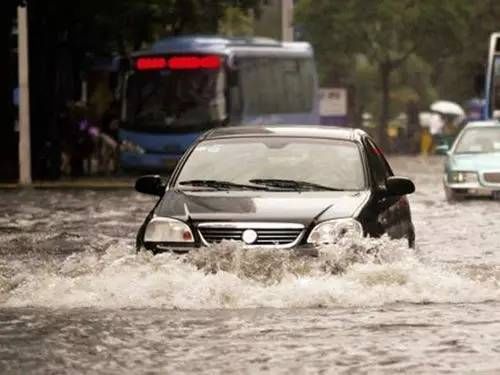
[{"xmin": 126, "ymin": 69, "xmax": 227, "ymax": 130}]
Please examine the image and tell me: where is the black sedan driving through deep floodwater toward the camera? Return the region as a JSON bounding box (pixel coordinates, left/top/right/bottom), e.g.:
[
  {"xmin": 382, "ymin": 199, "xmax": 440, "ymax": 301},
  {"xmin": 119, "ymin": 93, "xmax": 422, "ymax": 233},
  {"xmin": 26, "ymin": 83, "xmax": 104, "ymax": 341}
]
[{"xmin": 136, "ymin": 126, "xmax": 415, "ymax": 253}]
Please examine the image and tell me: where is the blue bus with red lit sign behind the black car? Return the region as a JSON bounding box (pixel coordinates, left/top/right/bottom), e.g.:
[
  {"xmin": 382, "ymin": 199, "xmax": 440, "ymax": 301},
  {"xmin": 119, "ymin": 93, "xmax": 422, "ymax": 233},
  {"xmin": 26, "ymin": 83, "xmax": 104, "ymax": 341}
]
[{"xmin": 119, "ymin": 36, "xmax": 320, "ymax": 170}]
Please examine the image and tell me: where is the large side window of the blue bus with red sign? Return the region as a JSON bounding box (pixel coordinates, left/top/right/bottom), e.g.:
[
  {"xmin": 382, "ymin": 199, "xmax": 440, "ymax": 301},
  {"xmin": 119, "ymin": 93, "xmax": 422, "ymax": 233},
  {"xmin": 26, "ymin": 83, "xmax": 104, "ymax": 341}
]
[{"xmin": 239, "ymin": 57, "xmax": 315, "ymax": 115}]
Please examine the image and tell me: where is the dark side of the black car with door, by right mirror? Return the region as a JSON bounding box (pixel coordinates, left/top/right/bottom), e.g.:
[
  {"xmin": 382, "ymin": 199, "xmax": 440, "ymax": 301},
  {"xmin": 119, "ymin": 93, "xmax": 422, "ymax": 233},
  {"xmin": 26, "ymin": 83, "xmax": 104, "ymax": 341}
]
[{"xmin": 365, "ymin": 138, "xmax": 414, "ymax": 245}]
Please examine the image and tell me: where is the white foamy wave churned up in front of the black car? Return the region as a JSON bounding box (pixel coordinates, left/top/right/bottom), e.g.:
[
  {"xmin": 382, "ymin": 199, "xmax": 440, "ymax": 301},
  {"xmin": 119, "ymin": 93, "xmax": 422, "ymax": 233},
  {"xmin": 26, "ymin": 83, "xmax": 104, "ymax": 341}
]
[{"xmin": 0, "ymin": 238, "xmax": 500, "ymax": 309}]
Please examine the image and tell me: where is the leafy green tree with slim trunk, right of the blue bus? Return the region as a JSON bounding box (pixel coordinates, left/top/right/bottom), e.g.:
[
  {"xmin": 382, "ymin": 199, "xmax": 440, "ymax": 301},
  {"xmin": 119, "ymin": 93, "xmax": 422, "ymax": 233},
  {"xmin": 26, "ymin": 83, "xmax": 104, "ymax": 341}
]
[{"xmin": 296, "ymin": 0, "xmax": 470, "ymax": 147}]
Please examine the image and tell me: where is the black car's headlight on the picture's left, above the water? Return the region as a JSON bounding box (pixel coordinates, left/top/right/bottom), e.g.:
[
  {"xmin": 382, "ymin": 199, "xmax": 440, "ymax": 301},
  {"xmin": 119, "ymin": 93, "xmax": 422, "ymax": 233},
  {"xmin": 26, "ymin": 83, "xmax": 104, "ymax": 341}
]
[{"xmin": 144, "ymin": 217, "xmax": 194, "ymax": 243}]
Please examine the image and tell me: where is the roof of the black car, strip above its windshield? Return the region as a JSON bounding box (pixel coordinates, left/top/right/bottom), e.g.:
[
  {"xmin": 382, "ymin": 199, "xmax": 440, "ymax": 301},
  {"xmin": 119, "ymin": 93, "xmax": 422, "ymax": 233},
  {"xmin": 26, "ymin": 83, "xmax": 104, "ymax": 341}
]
[{"xmin": 202, "ymin": 125, "xmax": 367, "ymax": 141}]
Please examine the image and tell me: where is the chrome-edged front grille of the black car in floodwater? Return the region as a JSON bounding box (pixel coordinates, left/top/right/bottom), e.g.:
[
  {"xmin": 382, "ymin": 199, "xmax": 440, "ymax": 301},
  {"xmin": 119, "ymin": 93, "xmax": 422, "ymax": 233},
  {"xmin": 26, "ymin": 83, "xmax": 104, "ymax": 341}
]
[{"xmin": 198, "ymin": 223, "xmax": 304, "ymax": 247}]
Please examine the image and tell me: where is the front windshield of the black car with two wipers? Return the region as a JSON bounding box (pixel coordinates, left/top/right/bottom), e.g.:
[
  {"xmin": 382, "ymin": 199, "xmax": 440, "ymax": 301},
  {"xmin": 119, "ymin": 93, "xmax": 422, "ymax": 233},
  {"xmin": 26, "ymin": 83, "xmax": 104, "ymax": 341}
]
[{"xmin": 176, "ymin": 137, "xmax": 365, "ymax": 190}]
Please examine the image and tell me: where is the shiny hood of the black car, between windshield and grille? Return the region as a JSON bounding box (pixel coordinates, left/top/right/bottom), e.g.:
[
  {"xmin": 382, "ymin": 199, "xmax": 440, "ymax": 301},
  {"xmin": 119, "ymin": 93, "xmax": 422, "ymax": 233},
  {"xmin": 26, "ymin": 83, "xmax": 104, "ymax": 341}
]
[{"xmin": 155, "ymin": 191, "xmax": 370, "ymax": 226}]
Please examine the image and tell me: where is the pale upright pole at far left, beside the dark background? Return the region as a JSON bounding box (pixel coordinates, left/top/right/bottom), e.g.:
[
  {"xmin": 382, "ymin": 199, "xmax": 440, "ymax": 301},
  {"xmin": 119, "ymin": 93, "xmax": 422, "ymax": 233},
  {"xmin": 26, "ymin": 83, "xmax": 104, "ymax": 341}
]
[{"xmin": 17, "ymin": 5, "xmax": 31, "ymax": 185}]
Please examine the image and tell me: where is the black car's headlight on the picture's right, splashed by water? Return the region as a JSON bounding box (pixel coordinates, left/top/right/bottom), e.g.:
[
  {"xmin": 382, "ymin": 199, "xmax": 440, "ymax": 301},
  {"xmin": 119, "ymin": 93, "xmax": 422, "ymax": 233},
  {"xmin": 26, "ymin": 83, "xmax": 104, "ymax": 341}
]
[{"xmin": 307, "ymin": 219, "xmax": 363, "ymax": 245}]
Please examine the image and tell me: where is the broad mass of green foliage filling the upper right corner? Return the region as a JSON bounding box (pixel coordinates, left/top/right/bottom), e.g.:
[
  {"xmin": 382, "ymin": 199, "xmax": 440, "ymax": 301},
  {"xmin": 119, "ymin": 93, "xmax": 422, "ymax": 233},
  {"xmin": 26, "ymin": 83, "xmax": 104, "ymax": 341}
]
[{"xmin": 295, "ymin": 0, "xmax": 500, "ymax": 145}]
